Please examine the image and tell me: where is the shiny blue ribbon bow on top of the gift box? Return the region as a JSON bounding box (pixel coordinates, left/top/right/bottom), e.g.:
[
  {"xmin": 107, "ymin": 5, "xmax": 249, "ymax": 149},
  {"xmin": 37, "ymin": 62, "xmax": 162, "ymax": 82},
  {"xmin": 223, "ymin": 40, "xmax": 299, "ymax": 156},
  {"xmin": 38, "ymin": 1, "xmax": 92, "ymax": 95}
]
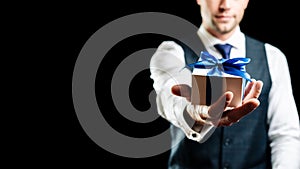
[{"xmin": 187, "ymin": 51, "xmax": 251, "ymax": 82}]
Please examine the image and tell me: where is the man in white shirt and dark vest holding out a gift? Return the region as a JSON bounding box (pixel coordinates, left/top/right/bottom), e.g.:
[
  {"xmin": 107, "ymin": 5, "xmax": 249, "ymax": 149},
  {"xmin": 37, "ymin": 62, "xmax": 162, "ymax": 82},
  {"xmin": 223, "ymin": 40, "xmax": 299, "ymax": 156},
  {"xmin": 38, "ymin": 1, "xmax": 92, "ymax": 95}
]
[{"xmin": 150, "ymin": 0, "xmax": 300, "ymax": 169}]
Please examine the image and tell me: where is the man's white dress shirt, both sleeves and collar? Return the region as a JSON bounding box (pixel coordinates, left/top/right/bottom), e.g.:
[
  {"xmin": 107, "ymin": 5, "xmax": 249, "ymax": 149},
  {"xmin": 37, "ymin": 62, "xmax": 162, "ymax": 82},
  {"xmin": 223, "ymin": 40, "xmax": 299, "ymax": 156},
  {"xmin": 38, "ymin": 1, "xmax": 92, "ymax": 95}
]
[{"xmin": 150, "ymin": 26, "xmax": 300, "ymax": 169}]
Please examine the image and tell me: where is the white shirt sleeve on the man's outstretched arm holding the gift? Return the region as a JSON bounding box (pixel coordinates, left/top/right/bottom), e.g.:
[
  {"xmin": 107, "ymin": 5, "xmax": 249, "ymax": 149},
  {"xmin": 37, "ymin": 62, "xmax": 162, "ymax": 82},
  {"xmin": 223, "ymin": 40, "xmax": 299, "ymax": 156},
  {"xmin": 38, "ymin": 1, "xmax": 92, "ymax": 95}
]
[{"xmin": 150, "ymin": 41, "xmax": 215, "ymax": 142}]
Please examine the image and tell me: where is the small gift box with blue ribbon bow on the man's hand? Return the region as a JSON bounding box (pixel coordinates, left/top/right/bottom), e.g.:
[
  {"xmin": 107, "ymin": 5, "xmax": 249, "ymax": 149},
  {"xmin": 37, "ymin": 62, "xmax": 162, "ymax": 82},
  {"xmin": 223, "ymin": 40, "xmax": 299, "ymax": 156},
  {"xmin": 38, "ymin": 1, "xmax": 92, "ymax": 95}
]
[{"xmin": 188, "ymin": 52, "xmax": 251, "ymax": 107}]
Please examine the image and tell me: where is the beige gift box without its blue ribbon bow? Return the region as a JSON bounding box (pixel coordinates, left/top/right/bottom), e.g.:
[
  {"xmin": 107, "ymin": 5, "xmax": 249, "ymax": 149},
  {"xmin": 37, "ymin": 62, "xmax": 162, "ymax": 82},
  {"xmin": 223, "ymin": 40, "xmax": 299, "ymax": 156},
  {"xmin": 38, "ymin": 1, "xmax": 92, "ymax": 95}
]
[{"xmin": 191, "ymin": 69, "xmax": 245, "ymax": 107}]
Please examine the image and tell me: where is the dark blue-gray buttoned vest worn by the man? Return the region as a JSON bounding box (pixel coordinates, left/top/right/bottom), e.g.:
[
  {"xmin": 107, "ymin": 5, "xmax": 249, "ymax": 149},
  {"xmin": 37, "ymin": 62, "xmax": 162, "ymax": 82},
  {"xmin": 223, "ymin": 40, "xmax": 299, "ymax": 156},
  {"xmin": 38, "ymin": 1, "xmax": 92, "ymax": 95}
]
[{"xmin": 169, "ymin": 36, "xmax": 271, "ymax": 169}]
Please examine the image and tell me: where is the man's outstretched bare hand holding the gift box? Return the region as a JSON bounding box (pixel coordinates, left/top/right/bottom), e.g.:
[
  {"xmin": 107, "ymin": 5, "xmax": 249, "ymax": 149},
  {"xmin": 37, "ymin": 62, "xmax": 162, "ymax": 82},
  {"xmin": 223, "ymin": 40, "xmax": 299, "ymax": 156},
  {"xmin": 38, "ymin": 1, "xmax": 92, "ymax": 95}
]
[{"xmin": 172, "ymin": 79, "xmax": 263, "ymax": 126}]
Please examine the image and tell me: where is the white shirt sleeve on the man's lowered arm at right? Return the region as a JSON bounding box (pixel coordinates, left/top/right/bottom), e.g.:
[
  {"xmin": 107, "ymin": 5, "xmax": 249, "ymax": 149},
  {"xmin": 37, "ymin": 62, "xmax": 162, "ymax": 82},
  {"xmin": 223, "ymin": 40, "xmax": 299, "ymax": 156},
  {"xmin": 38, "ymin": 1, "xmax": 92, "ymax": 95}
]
[{"xmin": 265, "ymin": 44, "xmax": 300, "ymax": 169}]
